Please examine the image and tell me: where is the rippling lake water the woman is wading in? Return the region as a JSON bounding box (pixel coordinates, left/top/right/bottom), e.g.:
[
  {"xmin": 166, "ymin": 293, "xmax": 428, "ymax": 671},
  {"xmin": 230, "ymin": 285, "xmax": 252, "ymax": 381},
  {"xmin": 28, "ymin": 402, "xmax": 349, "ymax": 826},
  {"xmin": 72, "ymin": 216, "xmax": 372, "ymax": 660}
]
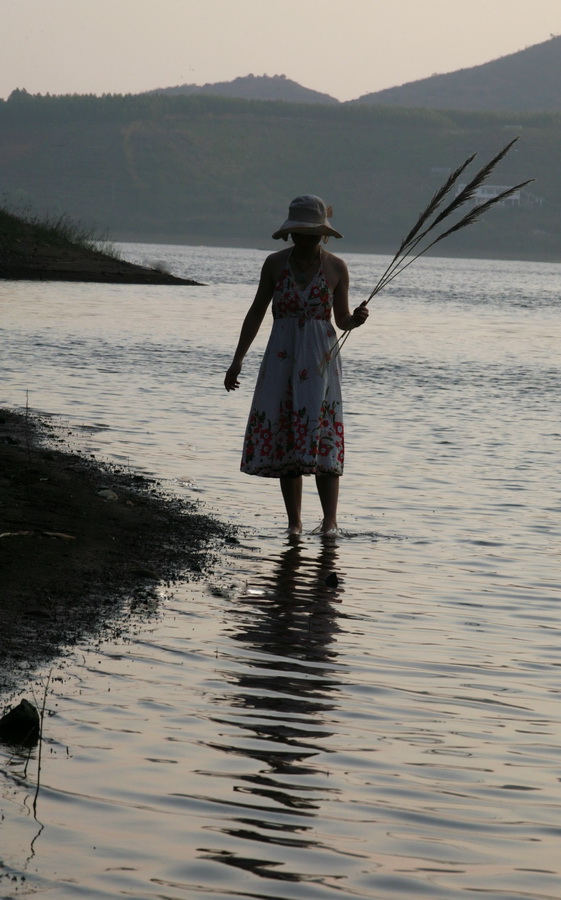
[{"xmin": 0, "ymin": 245, "xmax": 561, "ymax": 900}]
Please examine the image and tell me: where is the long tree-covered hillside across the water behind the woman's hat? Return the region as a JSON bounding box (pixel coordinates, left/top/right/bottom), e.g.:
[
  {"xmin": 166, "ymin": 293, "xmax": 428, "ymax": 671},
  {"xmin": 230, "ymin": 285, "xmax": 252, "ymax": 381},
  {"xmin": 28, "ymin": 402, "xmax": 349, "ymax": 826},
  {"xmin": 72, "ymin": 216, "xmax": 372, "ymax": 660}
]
[{"xmin": 0, "ymin": 91, "xmax": 561, "ymax": 259}]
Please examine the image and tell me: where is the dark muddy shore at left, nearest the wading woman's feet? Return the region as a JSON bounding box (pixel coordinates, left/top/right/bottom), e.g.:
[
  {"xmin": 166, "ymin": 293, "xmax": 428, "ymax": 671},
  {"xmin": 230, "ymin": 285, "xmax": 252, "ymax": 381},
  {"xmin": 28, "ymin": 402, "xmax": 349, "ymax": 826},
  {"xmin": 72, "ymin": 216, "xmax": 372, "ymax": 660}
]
[{"xmin": 0, "ymin": 410, "xmax": 233, "ymax": 705}]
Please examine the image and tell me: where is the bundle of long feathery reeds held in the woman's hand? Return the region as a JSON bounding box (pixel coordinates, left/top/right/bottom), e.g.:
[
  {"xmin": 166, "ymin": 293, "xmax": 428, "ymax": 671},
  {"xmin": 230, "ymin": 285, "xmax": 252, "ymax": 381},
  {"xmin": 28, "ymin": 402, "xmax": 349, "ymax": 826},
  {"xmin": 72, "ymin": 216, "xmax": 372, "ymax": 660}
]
[{"xmin": 322, "ymin": 138, "xmax": 534, "ymax": 367}]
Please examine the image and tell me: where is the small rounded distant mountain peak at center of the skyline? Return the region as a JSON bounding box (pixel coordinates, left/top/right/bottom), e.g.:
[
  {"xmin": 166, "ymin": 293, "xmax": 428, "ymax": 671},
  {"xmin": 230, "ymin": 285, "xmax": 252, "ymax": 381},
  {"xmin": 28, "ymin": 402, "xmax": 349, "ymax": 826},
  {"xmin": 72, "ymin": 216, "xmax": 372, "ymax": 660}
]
[{"xmin": 147, "ymin": 75, "xmax": 339, "ymax": 104}]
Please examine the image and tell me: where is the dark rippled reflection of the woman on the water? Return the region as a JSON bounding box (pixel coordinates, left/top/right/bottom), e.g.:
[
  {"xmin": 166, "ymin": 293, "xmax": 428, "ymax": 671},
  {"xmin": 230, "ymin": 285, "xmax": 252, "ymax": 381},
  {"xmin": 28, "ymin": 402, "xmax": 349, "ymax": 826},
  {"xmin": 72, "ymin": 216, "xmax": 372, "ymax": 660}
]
[{"xmin": 200, "ymin": 537, "xmax": 344, "ymax": 882}]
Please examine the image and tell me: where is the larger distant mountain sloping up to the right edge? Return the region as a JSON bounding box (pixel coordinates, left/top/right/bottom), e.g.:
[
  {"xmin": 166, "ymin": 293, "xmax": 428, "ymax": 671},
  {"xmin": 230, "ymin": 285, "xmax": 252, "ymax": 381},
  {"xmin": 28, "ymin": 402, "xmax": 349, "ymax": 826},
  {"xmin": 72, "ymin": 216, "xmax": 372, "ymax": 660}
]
[{"xmin": 350, "ymin": 37, "xmax": 561, "ymax": 113}]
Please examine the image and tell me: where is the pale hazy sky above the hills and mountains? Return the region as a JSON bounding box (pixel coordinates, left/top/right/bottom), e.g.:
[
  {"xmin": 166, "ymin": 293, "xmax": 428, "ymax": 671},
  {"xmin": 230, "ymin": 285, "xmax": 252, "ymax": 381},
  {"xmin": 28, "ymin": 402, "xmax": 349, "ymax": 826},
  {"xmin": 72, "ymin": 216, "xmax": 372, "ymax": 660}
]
[{"xmin": 0, "ymin": 0, "xmax": 561, "ymax": 100}]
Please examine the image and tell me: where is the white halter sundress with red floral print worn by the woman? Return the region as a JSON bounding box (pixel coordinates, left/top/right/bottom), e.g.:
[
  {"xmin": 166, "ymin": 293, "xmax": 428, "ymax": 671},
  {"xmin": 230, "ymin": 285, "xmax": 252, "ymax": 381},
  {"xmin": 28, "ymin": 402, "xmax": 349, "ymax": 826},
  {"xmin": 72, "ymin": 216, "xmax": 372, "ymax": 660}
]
[{"xmin": 240, "ymin": 250, "xmax": 345, "ymax": 478}]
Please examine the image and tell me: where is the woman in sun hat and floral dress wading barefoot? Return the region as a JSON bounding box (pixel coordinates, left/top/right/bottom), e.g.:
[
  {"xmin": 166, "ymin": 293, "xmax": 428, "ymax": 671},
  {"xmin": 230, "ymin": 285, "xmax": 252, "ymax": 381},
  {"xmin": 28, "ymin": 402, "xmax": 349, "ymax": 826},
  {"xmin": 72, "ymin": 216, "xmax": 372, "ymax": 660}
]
[{"xmin": 224, "ymin": 194, "xmax": 368, "ymax": 534}]
